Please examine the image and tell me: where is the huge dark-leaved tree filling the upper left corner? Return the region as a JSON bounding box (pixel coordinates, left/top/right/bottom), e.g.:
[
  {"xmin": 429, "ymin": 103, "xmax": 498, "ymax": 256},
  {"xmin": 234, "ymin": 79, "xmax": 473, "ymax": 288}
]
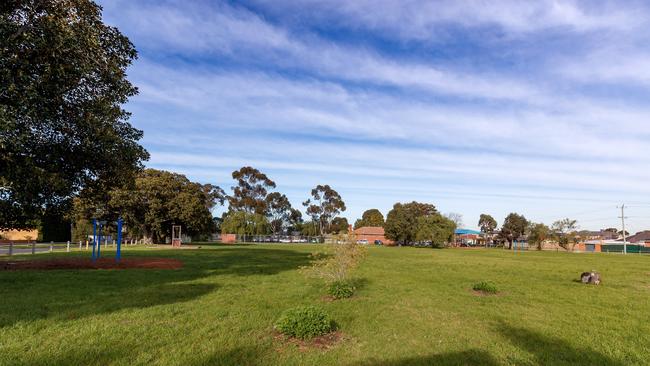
[{"xmin": 0, "ymin": 0, "xmax": 148, "ymax": 228}]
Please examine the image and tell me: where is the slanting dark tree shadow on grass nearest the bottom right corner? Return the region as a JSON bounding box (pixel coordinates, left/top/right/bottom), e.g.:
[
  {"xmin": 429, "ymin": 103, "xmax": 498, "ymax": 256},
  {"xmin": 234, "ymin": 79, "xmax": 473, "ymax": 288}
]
[{"xmin": 498, "ymin": 323, "xmax": 624, "ymax": 366}]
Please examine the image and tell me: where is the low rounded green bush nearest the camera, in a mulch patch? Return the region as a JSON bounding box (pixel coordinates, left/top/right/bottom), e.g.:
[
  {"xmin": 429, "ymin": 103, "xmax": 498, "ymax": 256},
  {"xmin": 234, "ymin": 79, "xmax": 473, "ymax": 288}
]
[{"xmin": 275, "ymin": 306, "xmax": 336, "ymax": 339}]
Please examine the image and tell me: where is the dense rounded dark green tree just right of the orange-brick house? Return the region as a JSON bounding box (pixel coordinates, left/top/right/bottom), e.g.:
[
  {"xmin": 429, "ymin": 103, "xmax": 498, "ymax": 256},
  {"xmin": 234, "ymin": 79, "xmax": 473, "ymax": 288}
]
[{"xmin": 384, "ymin": 201, "xmax": 439, "ymax": 244}]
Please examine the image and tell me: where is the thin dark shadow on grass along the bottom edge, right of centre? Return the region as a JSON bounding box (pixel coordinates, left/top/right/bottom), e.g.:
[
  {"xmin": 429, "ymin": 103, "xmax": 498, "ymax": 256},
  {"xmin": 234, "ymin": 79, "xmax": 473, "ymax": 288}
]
[{"xmin": 355, "ymin": 350, "xmax": 499, "ymax": 366}]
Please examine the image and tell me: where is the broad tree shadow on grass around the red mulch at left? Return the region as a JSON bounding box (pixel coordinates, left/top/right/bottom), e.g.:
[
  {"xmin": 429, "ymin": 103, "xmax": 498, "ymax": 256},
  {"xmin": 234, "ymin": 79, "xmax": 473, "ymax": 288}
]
[{"xmin": 0, "ymin": 248, "xmax": 309, "ymax": 329}]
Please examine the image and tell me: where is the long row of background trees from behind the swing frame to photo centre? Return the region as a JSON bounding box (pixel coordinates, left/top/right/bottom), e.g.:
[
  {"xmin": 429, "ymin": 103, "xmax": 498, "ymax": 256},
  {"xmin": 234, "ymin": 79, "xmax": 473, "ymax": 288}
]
[{"xmin": 72, "ymin": 166, "xmax": 348, "ymax": 242}]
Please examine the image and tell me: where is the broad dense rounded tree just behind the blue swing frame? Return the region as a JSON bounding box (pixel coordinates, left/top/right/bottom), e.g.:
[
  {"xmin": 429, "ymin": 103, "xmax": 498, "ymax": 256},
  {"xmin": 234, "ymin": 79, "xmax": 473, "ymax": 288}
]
[{"xmin": 104, "ymin": 169, "xmax": 219, "ymax": 242}]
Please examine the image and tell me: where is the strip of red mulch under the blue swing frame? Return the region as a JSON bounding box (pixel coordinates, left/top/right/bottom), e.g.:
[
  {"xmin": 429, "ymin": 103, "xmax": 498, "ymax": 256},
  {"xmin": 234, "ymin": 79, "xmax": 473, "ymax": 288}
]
[{"xmin": 0, "ymin": 258, "xmax": 183, "ymax": 271}]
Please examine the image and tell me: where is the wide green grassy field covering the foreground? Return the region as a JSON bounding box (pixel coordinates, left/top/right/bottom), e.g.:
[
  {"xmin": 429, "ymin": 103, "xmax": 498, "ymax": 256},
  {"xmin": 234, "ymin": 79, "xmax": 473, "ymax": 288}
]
[{"xmin": 0, "ymin": 245, "xmax": 650, "ymax": 365}]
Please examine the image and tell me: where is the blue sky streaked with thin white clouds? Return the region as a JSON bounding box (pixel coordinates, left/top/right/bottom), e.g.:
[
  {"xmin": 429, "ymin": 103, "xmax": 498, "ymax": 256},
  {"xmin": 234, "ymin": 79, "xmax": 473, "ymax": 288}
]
[{"xmin": 99, "ymin": 0, "xmax": 650, "ymax": 231}]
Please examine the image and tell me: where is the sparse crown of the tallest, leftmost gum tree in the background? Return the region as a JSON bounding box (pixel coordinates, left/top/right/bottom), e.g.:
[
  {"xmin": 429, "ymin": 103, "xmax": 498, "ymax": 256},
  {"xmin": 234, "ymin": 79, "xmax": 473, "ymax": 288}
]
[{"xmin": 228, "ymin": 166, "xmax": 276, "ymax": 215}]
